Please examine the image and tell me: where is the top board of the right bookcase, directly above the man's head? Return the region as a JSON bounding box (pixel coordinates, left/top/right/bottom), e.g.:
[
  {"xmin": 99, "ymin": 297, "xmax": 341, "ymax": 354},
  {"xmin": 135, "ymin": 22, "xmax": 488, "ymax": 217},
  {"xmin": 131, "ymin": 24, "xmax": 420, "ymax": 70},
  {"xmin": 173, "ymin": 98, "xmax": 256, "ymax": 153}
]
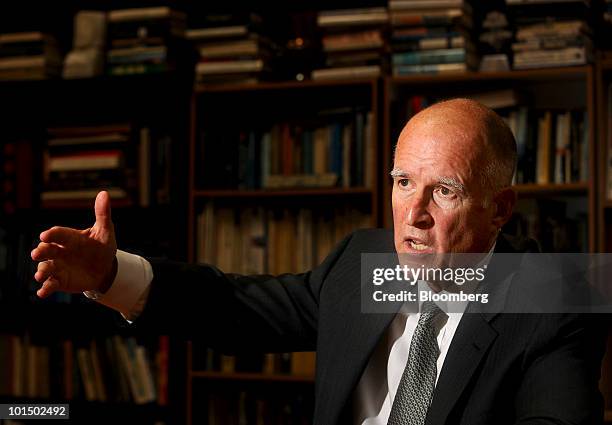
[{"xmin": 389, "ymin": 66, "xmax": 589, "ymax": 84}]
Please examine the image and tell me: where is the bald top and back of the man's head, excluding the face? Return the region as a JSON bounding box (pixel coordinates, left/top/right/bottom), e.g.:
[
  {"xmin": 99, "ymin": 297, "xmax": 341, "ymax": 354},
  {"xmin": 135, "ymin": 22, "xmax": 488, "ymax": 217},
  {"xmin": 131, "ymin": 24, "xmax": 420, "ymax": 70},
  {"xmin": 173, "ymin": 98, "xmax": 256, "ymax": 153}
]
[{"xmin": 398, "ymin": 99, "xmax": 517, "ymax": 191}]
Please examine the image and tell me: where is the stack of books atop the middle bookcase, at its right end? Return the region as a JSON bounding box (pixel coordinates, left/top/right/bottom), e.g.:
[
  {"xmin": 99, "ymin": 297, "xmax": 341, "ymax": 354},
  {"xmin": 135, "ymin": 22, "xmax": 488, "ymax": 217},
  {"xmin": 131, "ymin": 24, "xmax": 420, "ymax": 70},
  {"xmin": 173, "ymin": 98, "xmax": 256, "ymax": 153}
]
[{"xmin": 311, "ymin": 8, "xmax": 389, "ymax": 80}]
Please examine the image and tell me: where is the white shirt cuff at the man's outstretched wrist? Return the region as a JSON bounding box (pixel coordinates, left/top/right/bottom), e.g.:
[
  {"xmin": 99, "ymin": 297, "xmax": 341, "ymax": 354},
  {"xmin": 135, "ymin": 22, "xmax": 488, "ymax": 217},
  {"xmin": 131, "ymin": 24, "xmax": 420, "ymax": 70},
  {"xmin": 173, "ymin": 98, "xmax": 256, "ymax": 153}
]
[{"xmin": 84, "ymin": 250, "xmax": 153, "ymax": 321}]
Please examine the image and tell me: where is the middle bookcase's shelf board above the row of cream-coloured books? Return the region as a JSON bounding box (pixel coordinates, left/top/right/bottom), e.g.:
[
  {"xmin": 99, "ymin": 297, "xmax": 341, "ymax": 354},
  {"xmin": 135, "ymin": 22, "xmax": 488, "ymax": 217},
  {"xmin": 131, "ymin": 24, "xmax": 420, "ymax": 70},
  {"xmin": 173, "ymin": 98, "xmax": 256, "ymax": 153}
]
[{"xmin": 193, "ymin": 187, "xmax": 372, "ymax": 198}]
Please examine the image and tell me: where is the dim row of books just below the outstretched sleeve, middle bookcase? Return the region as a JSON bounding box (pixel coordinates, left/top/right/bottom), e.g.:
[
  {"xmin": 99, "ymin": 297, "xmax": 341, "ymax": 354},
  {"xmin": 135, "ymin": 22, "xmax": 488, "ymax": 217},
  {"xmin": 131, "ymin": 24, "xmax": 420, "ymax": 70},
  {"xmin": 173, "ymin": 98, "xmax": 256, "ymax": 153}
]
[{"xmin": 193, "ymin": 344, "xmax": 316, "ymax": 379}]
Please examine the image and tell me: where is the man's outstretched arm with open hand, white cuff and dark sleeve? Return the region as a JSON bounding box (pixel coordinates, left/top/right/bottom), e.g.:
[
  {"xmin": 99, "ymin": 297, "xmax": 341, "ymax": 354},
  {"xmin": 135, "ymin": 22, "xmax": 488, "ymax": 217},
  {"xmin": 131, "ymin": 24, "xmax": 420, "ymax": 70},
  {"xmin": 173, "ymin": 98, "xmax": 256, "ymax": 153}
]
[{"xmin": 32, "ymin": 192, "xmax": 350, "ymax": 351}]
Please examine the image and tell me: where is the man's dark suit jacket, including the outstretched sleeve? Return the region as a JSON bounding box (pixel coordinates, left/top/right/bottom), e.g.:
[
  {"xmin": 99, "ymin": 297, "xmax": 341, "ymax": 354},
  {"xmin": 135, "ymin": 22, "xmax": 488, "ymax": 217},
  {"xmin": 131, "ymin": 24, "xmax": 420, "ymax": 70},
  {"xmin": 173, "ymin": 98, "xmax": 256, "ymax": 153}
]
[{"xmin": 135, "ymin": 230, "xmax": 605, "ymax": 425}]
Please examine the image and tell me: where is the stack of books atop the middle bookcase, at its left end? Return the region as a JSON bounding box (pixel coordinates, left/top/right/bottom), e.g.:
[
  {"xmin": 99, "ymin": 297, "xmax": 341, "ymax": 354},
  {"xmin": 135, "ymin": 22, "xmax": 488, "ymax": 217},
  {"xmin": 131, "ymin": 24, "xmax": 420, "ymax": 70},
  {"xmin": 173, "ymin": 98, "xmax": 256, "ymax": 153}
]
[{"xmin": 187, "ymin": 14, "xmax": 274, "ymax": 84}]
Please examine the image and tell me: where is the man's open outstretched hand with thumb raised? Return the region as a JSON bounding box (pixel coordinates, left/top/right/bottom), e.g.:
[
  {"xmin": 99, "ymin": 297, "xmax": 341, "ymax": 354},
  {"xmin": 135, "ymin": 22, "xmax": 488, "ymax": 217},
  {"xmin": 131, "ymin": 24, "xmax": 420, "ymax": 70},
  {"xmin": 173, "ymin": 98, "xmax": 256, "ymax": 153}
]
[{"xmin": 31, "ymin": 191, "xmax": 117, "ymax": 298}]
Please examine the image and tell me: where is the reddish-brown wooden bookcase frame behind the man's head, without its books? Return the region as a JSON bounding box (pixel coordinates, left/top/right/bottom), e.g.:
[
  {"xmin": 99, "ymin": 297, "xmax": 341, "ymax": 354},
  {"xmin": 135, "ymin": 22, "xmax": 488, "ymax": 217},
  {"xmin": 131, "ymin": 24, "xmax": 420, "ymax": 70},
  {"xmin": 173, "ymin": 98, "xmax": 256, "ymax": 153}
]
[{"xmin": 381, "ymin": 66, "xmax": 599, "ymax": 252}]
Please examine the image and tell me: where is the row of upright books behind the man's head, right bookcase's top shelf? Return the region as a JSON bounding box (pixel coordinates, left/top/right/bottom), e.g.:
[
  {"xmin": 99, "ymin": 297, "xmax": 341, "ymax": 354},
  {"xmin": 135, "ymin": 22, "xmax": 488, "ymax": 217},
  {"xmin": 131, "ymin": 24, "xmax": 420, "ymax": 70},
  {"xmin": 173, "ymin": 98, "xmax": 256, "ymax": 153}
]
[{"xmin": 398, "ymin": 90, "xmax": 589, "ymax": 184}]
